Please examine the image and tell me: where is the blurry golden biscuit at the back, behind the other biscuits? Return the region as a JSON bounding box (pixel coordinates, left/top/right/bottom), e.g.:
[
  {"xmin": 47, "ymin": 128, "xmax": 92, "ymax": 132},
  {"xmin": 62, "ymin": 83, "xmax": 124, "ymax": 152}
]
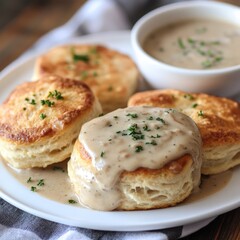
[{"xmin": 34, "ymin": 45, "xmax": 139, "ymax": 113}]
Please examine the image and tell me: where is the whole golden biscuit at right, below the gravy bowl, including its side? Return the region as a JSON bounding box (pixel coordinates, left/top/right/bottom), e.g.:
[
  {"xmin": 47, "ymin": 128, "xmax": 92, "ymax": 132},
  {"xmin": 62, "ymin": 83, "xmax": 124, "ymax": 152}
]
[{"xmin": 128, "ymin": 90, "xmax": 240, "ymax": 174}]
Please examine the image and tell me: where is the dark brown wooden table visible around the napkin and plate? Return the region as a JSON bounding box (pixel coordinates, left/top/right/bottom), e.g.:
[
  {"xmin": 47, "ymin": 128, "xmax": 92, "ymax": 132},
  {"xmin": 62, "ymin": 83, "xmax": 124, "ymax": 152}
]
[{"xmin": 0, "ymin": 0, "xmax": 240, "ymax": 240}]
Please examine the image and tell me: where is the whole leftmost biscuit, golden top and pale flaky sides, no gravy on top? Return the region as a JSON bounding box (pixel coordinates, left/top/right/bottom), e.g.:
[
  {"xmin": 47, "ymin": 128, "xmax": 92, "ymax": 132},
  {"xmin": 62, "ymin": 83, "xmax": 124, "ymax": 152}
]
[{"xmin": 0, "ymin": 76, "xmax": 101, "ymax": 168}]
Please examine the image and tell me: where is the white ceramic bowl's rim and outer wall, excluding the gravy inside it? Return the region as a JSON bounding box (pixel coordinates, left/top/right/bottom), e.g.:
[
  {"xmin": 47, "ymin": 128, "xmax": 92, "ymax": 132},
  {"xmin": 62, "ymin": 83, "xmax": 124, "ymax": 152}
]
[{"xmin": 131, "ymin": 1, "xmax": 240, "ymax": 96}]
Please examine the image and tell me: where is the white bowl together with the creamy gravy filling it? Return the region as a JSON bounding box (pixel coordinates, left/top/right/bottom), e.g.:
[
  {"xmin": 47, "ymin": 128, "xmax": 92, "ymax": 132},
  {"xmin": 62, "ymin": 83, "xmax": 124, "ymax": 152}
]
[{"xmin": 131, "ymin": 1, "xmax": 240, "ymax": 97}]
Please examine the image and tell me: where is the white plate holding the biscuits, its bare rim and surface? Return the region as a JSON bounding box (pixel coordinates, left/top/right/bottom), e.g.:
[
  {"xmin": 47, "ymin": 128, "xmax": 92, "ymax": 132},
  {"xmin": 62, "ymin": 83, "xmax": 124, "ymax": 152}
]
[{"xmin": 0, "ymin": 32, "xmax": 240, "ymax": 231}]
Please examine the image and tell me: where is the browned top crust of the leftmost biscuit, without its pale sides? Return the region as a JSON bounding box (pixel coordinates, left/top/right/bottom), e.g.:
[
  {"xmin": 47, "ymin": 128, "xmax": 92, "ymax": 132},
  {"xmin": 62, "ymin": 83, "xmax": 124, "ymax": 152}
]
[{"xmin": 0, "ymin": 76, "xmax": 94, "ymax": 144}]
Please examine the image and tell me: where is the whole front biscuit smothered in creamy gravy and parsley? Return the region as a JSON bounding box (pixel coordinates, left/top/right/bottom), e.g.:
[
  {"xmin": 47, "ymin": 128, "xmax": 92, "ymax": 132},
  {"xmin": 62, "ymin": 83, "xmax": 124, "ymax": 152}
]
[{"xmin": 68, "ymin": 107, "xmax": 202, "ymax": 210}]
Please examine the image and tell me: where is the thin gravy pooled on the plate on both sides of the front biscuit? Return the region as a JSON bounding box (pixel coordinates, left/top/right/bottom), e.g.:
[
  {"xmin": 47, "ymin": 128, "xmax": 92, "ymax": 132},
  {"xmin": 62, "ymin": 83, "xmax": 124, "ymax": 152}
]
[{"xmin": 6, "ymin": 162, "xmax": 232, "ymax": 207}]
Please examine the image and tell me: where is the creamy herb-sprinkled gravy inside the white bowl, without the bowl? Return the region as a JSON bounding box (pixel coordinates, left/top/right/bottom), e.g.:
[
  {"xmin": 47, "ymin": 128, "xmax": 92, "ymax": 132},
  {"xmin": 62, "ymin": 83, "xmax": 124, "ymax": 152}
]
[{"xmin": 143, "ymin": 19, "xmax": 240, "ymax": 69}]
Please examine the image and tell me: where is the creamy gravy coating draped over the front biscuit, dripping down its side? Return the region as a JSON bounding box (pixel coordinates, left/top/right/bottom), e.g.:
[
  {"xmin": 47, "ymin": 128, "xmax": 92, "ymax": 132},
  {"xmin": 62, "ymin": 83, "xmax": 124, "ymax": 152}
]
[{"xmin": 68, "ymin": 106, "xmax": 202, "ymax": 210}]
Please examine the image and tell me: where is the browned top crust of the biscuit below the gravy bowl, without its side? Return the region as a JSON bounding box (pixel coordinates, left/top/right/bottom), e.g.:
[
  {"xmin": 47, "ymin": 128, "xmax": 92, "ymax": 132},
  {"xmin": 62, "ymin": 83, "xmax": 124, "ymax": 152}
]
[{"xmin": 128, "ymin": 89, "xmax": 240, "ymax": 147}]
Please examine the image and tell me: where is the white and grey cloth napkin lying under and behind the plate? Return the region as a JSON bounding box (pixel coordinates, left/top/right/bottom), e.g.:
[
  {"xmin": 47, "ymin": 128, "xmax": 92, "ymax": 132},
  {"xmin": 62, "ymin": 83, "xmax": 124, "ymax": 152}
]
[{"xmin": 0, "ymin": 0, "xmax": 216, "ymax": 240}]
